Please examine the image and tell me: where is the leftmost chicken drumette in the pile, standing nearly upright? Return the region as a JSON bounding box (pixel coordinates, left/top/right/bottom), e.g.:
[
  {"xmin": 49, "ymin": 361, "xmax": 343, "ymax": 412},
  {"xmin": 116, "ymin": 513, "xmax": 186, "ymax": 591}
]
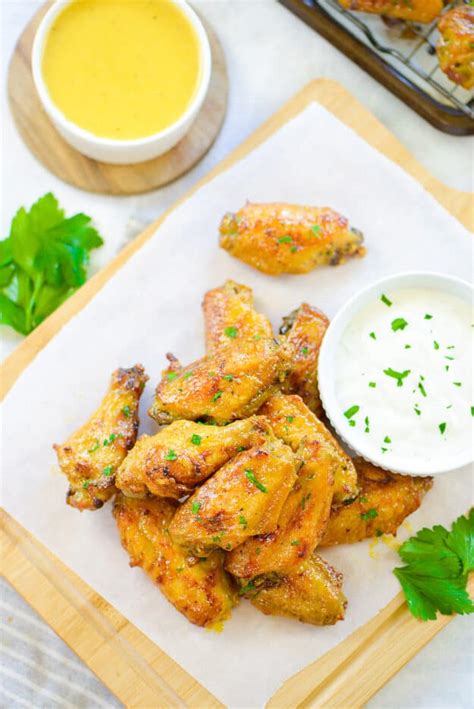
[{"xmin": 54, "ymin": 364, "xmax": 148, "ymax": 511}]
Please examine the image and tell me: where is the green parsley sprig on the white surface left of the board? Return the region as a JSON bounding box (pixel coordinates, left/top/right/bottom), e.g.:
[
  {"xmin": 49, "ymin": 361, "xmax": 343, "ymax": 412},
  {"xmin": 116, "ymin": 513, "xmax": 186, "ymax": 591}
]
[{"xmin": 0, "ymin": 192, "xmax": 103, "ymax": 335}]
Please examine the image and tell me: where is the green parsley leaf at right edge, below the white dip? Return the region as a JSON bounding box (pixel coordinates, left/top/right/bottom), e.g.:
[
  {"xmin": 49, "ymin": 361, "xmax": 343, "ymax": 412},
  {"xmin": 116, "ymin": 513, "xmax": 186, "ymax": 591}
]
[{"xmin": 393, "ymin": 508, "xmax": 474, "ymax": 620}]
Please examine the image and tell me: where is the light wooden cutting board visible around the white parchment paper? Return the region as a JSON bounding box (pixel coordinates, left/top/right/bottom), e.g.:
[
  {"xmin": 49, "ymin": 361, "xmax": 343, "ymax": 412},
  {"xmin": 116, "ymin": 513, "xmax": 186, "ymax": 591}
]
[{"xmin": 0, "ymin": 79, "xmax": 474, "ymax": 709}]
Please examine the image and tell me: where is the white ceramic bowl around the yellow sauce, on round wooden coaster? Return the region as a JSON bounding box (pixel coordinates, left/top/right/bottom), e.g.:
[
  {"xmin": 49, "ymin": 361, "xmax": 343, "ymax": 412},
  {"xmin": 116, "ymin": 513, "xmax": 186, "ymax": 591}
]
[{"xmin": 32, "ymin": 0, "xmax": 211, "ymax": 164}]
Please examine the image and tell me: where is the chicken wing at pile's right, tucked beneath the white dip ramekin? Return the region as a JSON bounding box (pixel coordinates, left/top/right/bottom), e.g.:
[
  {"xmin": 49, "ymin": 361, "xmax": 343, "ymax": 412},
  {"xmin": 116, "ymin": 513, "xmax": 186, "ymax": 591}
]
[{"xmin": 321, "ymin": 458, "xmax": 433, "ymax": 546}]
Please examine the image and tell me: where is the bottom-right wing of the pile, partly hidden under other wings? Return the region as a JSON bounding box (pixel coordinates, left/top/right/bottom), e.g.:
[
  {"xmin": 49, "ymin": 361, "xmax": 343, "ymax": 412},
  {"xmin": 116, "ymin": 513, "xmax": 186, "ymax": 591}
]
[{"xmin": 244, "ymin": 555, "xmax": 347, "ymax": 625}]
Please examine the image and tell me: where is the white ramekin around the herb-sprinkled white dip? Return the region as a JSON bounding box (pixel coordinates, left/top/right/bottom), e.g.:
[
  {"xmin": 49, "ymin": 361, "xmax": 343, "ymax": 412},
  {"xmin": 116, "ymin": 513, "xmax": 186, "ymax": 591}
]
[{"xmin": 318, "ymin": 271, "xmax": 473, "ymax": 475}]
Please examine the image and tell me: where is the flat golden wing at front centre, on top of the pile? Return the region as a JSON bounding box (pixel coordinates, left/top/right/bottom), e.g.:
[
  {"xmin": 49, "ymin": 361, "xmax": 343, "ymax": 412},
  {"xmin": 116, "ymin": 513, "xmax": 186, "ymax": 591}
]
[{"xmin": 170, "ymin": 439, "xmax": 296, "ymax": 553}]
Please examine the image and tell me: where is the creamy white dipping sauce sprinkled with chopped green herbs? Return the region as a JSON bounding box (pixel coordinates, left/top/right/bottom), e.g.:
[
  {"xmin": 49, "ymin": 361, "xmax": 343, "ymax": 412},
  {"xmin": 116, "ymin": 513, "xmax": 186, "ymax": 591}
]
[{"xmin": 335, "ymin": 288, "xmax": 474, "ymax": 468}]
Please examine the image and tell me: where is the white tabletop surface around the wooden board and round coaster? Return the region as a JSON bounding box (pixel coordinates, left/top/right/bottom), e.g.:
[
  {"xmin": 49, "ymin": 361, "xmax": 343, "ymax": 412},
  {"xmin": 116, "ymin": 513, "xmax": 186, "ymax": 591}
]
[{"xmin": 0, "ymin": 0, "xmax": 474, "ymax": 709}]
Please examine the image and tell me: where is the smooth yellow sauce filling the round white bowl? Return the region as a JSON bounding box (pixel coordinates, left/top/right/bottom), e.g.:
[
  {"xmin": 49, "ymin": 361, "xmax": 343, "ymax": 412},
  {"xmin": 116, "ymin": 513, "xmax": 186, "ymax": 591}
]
[{"xmin": 42, "ymin": 0, "xmax": 201, "ymax": 140}]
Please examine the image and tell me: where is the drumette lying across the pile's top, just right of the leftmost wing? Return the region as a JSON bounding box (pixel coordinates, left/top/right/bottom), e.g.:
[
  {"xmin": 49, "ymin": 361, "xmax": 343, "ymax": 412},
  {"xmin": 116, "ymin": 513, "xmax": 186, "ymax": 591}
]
[{"xmin": 116, "ymin": 416, "xmax": 272, "ymax": 500}]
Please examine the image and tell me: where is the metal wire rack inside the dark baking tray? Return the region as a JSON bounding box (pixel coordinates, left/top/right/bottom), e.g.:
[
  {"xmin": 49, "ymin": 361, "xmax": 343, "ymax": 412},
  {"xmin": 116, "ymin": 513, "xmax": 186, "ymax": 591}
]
[{"xmin": 322, "ymin": 0, "xmax": 474, "ymax": 119}]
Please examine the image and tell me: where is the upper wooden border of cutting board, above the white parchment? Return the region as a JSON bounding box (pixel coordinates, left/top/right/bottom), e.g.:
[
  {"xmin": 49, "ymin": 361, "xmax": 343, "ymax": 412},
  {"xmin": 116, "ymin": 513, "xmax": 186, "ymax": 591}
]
[{"xmin": 0, "ymin": 79, "xmax": 474, "ymax": 400}]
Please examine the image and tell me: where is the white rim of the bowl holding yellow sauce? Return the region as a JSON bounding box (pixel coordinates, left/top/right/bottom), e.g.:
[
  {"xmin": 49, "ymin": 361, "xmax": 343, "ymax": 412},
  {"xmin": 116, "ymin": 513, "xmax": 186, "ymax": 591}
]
[{"xmin": 32, "ymin": 0, "xmax": 211, "ymax": 148}]
